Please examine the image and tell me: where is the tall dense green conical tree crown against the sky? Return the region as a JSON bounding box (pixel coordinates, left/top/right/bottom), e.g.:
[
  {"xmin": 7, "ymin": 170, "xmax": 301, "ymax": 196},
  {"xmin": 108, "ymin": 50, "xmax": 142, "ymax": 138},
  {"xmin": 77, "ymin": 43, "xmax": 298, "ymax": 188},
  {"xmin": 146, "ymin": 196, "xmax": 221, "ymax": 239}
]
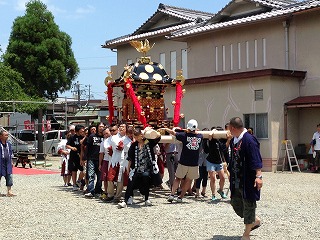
[{"xmin": 4, "ymin": 0, "xmax": 79, "ymax": 100}]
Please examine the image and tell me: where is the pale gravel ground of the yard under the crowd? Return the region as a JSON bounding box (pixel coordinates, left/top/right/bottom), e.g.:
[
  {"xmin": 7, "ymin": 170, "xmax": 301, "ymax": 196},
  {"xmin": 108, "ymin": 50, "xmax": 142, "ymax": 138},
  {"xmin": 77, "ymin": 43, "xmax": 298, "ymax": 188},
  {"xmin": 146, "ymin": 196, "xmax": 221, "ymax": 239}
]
[{"xmin": 0, "ymin": 158, "xmax": 320, "ymax": 240}]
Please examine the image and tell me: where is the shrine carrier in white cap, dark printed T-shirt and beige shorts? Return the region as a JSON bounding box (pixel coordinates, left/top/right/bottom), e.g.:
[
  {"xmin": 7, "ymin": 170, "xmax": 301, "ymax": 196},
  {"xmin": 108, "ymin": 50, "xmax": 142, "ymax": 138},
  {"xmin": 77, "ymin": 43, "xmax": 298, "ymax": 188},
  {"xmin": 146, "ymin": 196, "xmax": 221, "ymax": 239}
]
[{"xmin": 165, "ymin": 119, "xmax": 203, "ymax": 202}]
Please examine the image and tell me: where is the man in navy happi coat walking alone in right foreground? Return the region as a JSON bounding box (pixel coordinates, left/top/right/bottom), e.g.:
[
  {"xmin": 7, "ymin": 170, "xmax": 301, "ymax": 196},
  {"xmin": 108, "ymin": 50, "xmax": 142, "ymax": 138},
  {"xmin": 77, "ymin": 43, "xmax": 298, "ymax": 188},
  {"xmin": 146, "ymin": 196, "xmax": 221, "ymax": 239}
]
[{"xmin": 228, "ymin": 117, "xmax": 262, "ymax": 240}]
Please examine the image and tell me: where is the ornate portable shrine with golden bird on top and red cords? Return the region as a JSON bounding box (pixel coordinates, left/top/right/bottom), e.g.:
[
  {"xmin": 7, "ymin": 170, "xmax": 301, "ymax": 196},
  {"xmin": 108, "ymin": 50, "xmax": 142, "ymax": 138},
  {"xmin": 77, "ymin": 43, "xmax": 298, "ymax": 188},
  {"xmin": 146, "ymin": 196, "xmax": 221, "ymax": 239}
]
[{"xmin": 105, "ymin": 40, "xmax": 185, "ymax": 128}]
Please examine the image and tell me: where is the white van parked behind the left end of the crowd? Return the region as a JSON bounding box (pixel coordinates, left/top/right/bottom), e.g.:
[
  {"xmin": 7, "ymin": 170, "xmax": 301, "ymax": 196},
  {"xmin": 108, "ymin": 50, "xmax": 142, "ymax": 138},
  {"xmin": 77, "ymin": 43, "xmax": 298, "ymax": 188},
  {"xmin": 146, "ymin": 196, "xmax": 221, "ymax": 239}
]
[{"xmin": 43, "ymin": 130, "xmax": 67, "ymax": 155}]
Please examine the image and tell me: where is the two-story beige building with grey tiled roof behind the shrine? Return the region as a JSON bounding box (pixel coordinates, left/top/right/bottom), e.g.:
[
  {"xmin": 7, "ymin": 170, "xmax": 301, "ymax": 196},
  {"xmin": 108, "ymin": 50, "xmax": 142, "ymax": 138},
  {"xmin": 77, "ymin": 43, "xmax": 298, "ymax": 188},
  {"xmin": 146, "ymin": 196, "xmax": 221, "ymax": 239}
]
[{"xmin": 104, "ymin": 0, "xmax": 320, "ymax": 171}]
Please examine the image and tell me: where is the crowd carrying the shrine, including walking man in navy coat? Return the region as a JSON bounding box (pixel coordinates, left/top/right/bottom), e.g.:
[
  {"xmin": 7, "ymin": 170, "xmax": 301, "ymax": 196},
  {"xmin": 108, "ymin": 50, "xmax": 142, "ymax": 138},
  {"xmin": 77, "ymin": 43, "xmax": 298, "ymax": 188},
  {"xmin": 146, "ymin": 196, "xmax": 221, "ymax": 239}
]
[{"xmin": 60, "ymin": 117, "xmax": 262, "ymax": 239}]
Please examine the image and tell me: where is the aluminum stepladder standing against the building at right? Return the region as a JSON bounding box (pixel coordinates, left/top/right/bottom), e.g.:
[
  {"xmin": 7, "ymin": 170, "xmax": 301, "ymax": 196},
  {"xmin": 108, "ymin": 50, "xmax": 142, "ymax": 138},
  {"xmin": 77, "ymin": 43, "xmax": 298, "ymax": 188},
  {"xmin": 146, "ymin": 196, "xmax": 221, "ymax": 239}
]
[{"xmin": 277, "ymin": 140, "xmax": 301, "ymax": 173}]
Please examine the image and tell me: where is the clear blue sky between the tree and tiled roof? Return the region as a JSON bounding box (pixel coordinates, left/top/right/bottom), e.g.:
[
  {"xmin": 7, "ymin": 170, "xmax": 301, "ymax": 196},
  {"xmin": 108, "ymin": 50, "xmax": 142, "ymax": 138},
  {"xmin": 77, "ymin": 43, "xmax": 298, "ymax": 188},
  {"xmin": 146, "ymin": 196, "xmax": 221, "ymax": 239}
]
[{"xmin": 0, "ymin": 0, "xmax": 230, "ymax": 99}]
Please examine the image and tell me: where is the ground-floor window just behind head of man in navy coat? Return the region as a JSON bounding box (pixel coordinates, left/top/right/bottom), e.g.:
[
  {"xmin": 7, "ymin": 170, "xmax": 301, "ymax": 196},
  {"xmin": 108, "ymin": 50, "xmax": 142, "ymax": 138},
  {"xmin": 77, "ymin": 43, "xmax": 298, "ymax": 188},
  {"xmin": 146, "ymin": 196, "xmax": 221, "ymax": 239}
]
[{"xmin": 244, "ymin": 113, "xmax": 268, "ymax": 138}]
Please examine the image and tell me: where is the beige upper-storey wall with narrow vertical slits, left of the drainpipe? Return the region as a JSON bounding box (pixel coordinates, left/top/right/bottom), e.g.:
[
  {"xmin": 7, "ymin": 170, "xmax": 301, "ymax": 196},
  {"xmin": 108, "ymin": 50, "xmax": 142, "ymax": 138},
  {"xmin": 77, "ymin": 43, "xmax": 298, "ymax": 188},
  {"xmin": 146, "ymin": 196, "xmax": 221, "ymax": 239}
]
[{"xmin": 188, "ymin": 21, "xmax": 285, "ymax": 78}]
